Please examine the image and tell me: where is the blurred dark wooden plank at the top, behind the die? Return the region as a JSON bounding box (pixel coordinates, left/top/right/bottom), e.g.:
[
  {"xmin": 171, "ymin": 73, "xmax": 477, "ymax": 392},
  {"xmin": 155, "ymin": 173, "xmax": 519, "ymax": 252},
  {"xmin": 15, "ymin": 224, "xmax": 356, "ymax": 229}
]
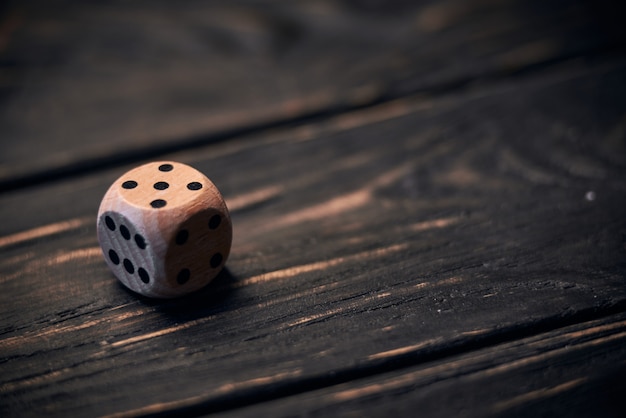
[{"xmin": 0, "ymin": 0, "xmax": 626, "ymax": 189}]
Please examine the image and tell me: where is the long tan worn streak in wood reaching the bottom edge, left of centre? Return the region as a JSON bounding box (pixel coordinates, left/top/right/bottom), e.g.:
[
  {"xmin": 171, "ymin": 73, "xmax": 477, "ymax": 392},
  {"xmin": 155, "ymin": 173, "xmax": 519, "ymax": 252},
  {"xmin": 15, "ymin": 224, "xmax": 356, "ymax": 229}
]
[{"xmin": 103, "ymin": 369, "xmax": 302, "ymax": 418}]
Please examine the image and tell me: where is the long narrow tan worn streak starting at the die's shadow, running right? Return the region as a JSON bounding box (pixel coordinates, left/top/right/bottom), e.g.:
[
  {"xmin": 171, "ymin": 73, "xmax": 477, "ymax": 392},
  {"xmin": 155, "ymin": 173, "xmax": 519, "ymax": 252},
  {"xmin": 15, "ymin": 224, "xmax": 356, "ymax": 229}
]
[{"xmin": 234, "ymin": 243, "xmax": 408, "ymax": 287}]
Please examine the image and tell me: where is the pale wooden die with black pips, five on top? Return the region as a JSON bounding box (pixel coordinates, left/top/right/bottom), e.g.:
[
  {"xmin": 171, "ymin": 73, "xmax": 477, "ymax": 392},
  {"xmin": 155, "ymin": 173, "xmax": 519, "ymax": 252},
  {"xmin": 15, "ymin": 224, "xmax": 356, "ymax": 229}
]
[{"xmin": 98, "ymin": 161, "xmax": 232, "ymax": 298}]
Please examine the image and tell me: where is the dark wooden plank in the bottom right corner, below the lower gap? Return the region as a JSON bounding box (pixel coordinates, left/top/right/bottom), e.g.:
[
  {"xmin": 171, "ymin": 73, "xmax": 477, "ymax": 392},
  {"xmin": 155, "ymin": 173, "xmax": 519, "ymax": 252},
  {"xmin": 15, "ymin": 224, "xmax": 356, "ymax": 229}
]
[{"xmin": 214, "ymin": 314, "xmax": 626, "ymax": 417}]
